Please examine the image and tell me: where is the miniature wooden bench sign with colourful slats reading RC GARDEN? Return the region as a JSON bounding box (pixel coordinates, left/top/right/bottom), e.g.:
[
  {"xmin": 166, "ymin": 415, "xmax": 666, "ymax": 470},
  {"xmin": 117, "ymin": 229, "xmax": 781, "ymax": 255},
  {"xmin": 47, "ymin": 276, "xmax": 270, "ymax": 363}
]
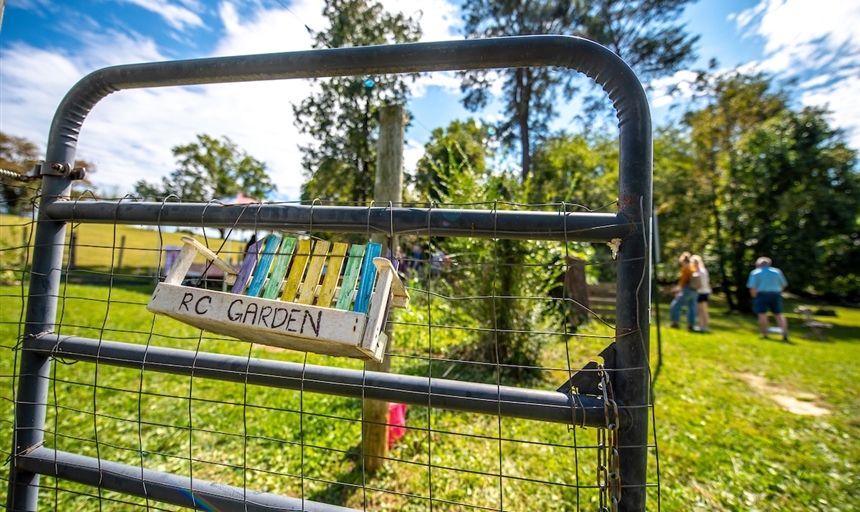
[{"xmin": 146, "ymin": 233, "xmax": 409, "ymax": 361}]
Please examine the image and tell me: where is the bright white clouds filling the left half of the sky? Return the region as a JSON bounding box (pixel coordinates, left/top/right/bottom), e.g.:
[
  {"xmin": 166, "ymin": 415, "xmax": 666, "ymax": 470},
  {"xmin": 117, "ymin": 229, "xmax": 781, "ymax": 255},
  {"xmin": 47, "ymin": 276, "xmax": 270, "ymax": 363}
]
[{"xmin": 0, "ymin": 0, "xmax": 470, "ymax": 199}]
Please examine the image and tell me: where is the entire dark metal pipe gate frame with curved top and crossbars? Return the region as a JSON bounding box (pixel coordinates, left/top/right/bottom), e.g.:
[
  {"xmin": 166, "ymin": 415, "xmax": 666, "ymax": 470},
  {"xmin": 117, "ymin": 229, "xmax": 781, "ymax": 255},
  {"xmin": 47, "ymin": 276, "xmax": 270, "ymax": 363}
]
[{"xmin": 7, "ymin": 36, "xmax": 653, "ymax": 511}]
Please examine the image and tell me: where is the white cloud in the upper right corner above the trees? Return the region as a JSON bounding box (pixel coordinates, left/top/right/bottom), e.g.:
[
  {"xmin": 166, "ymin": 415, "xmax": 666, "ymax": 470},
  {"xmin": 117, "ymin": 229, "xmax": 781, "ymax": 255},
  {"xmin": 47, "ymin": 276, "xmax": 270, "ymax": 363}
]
[{"xmin": 735, "ymin": 0, "xmax": 860, "ymax": 149}]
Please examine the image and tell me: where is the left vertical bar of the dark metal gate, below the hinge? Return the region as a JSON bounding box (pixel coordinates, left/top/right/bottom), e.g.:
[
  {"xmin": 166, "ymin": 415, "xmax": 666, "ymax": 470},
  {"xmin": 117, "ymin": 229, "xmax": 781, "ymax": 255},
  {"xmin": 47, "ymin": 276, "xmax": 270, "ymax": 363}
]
[{"xmin": 7, "ymin": 154, "xmax": 75, "ymax": 512}]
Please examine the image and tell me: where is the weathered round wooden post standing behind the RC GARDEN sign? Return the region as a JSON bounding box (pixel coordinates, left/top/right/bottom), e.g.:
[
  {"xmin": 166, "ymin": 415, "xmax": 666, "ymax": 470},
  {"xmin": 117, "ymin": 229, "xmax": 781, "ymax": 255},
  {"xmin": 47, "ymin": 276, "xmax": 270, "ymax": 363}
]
[{"xmin": 362, "ymin": 105, "xmax": 406, "ymax": 473}]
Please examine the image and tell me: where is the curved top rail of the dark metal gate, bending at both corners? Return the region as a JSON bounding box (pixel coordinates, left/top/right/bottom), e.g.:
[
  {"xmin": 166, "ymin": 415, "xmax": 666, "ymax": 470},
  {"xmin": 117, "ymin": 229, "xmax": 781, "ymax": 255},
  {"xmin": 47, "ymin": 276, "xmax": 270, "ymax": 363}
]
[{"xmin": 42, "ymin": 36, "xmax": 652, "ymax": 200}]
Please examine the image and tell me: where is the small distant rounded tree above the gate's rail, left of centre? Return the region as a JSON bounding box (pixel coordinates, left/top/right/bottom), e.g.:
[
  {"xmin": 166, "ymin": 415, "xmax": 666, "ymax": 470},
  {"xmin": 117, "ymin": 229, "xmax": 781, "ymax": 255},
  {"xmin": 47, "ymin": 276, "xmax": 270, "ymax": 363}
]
[{"xmin": 134, "ymin": 134, "xmax": 277, "ymax": 207}]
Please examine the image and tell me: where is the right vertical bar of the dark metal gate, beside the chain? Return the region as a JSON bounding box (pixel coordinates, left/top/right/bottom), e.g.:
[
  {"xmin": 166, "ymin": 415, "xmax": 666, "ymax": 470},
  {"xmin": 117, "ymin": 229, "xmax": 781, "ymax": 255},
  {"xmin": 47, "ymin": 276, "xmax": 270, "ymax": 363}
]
[{"xmin": 612, "ymin": 92, "xmax": 653, "ymax": 512}]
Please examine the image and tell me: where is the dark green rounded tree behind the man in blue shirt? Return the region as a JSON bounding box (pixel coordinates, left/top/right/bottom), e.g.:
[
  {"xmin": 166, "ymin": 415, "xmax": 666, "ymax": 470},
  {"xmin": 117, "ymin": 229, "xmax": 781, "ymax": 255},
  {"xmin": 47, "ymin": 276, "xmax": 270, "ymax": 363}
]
[{"xmin": 724, "ymin": 107, "xmax": 860, "ymax": 303}]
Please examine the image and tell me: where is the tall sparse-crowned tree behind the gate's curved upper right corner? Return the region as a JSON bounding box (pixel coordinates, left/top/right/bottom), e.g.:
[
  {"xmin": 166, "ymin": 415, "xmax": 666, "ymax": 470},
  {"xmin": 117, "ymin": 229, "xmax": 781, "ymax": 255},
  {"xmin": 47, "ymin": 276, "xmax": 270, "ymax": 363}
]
[{"xmin": 461, "ymin": 0, "xmax": 698, "ymax": 181}]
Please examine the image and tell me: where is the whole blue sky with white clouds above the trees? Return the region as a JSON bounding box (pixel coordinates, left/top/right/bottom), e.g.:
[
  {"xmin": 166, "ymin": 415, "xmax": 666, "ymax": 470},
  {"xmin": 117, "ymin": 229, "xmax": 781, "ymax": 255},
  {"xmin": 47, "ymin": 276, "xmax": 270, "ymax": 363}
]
[{"xmin": 0, "ymin": 0, "xmax": 860, "ymax": 200}]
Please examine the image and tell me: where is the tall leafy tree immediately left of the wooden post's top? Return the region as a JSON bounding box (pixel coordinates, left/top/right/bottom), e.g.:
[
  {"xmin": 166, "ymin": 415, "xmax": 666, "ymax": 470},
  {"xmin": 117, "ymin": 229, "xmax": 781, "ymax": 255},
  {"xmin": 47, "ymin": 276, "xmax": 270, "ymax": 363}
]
[{"xmin": 293, "ymin": 0, "xmax": 421, "ymax": 203}]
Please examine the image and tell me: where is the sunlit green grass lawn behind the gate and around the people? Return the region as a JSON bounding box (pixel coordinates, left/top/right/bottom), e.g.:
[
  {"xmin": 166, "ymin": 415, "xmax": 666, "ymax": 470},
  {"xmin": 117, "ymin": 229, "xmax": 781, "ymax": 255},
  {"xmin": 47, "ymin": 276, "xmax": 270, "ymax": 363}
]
[{"xmin": 0, "ymin": 216, "xmax": 860, "ymax": 511}]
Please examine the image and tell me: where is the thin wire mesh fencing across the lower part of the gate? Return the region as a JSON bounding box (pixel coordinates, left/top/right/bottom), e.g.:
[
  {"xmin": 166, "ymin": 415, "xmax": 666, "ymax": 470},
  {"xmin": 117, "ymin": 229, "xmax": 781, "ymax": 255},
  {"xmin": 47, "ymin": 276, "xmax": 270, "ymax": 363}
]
[{"xmin": 0, "ymin": 194, "xmax": 658, "ymax": 510}]
